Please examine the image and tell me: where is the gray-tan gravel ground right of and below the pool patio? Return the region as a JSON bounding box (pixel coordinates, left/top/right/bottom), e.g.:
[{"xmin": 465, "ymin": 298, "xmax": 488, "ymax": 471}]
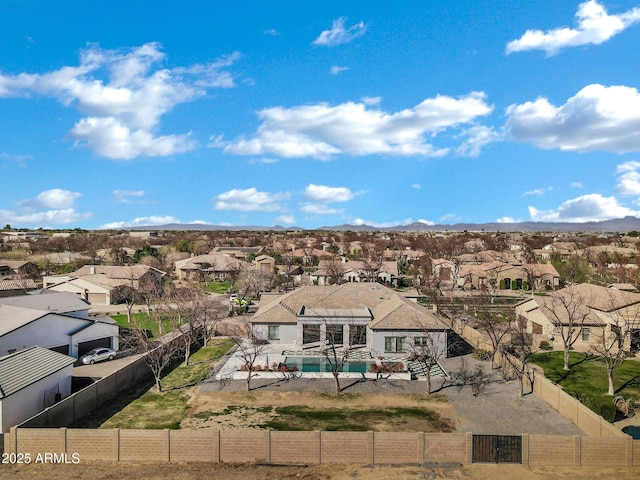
[{"xmin": 198, "ymin": 355, "xmax": 584, "ymax": 435}]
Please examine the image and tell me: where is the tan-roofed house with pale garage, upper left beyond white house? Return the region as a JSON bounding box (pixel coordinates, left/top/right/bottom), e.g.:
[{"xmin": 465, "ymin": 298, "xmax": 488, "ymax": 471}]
[{"xmin": 42, "ymin": 264, "xmax": 166, "ymax": 305}]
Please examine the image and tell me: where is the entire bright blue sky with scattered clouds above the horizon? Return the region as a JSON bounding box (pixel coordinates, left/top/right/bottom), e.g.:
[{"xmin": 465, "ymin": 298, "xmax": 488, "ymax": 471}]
[{"xmin": 0, "ymin": 0, "xmax": 640, "ymax": 229}]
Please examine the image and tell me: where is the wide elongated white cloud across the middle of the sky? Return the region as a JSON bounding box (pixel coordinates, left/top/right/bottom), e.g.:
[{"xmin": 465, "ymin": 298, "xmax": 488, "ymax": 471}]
[{"xmin": 218, "ymin": 92, "xmax": 493, "ymax": 160}]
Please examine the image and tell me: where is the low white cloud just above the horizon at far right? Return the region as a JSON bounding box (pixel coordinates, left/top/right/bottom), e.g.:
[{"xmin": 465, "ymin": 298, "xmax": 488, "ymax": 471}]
[{"xmin": 529, "ymin": 193, "xmax": 640, "ymax": 223}]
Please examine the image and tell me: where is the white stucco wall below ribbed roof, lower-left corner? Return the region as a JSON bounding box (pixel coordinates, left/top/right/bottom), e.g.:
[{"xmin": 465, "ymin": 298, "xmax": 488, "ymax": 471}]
[{"xmin": 0, "ymin": 365, "xmax": 73, "ymax": 433}]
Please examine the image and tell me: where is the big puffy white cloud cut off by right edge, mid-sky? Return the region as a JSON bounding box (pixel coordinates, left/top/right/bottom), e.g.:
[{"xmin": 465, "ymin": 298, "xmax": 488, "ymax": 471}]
[{"xmin": 504, "ymin": 84, "xmax": 640, "ymax": 153}]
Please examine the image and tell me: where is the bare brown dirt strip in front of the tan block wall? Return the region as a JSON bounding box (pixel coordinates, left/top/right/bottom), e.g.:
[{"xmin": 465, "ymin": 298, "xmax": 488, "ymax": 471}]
[{"xmin": 0, "ymin": 463, "xmax": 638, "ymax": 480}]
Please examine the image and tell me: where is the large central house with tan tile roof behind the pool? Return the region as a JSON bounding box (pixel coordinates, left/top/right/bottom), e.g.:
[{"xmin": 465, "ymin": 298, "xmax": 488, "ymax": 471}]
[{"xmin": 251, "ymin": 283, "xmax": 448, "ymax": 357}]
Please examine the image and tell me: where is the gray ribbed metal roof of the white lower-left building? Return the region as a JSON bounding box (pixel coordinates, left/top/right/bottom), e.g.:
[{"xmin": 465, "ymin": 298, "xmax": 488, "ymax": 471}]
[{"xmin": 0, "ymin": 347, "xmax": 75, "ymax": 399}]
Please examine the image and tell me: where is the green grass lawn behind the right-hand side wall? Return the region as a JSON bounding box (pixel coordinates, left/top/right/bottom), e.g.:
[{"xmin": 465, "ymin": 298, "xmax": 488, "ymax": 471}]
[{"xmin": 531, "ymin": 352, "xmax": 640, "ymax": 422}]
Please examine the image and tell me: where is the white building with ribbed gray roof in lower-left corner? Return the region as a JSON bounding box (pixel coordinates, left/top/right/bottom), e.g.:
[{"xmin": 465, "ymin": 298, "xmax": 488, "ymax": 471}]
[{"xmin": 0, "ymin": 347, "xmax": 75, "ymax": 433}]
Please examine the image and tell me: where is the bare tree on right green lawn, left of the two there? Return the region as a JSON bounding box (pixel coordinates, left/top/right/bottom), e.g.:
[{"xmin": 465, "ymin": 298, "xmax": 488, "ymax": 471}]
[{"xmin": 541, "ymin": 288, "xmax": 589, "ymax": 370}]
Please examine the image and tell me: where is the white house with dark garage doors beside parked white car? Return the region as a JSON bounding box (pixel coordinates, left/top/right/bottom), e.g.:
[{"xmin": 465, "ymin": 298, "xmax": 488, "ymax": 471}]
[{"xmin": 0, "ymin": 304, "xmax": 119, "ymax": 358}]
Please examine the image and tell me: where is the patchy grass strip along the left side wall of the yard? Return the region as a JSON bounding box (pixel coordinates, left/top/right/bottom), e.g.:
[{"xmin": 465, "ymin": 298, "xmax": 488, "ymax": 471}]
[{"xmin": 95, "ymin": 338, "xmax": 233, "ymax": 429}]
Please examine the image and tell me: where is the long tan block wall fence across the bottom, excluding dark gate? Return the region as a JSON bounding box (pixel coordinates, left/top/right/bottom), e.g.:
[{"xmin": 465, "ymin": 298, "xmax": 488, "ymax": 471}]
[{"xmin": 3, "ymin": 427, "xmax": 640, "ymax": 467}]
